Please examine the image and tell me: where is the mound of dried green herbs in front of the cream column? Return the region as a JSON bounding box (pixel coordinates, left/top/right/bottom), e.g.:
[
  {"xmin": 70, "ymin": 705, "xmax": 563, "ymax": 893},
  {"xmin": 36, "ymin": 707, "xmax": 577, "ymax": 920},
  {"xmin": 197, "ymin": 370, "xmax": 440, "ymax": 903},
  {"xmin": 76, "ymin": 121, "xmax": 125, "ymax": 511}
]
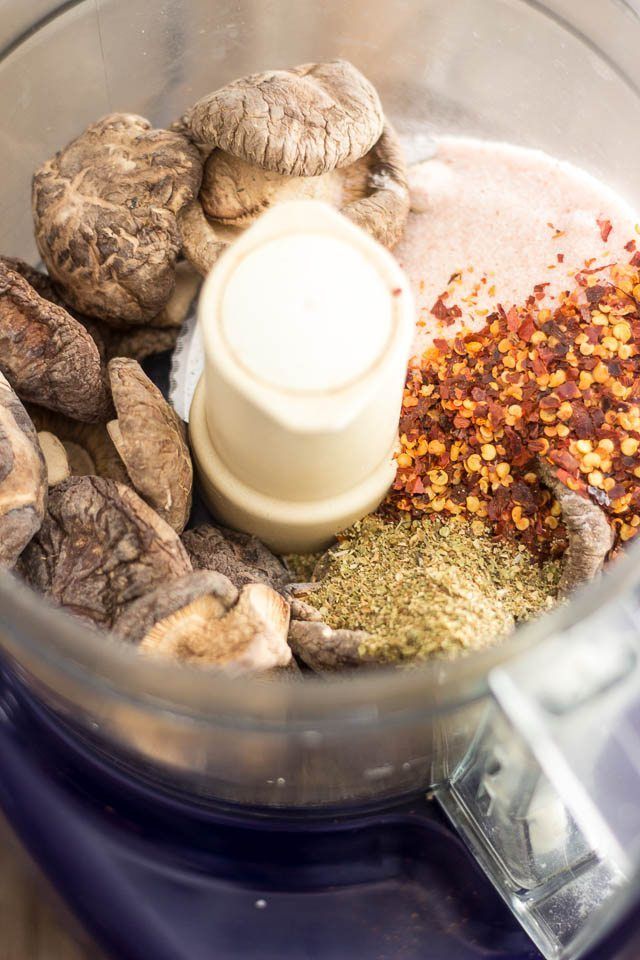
[{"xmin": 307, "ymin": 516, "xmax": 559, "ymax": 662}]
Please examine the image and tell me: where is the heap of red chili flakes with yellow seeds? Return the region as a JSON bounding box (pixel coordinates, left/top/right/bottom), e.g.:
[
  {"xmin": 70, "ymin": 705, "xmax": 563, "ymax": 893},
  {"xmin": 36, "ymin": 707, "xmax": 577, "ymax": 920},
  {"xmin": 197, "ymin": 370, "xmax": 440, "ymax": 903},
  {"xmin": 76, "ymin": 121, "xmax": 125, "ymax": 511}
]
[{"xmin": 386, "ymin": 249, "xmax": 640, "ymax": 555}]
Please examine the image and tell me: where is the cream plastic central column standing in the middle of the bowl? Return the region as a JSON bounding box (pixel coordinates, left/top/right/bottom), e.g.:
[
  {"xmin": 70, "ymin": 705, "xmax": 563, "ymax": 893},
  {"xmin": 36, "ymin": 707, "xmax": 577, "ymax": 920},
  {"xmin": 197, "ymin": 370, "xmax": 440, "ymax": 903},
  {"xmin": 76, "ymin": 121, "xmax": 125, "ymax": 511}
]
[{"xmin": 190, "ymin": 201, "xmax": 414, "ymax": 552}]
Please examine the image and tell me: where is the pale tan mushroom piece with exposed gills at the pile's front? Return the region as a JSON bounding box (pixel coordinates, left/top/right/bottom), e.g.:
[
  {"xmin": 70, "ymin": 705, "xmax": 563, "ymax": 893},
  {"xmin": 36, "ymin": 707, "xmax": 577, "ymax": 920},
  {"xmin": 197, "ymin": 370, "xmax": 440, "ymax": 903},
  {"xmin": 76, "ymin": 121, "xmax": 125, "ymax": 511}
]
[{"xmin": 140, "ymin": 583, "xmax": 291, "ymax": 672}]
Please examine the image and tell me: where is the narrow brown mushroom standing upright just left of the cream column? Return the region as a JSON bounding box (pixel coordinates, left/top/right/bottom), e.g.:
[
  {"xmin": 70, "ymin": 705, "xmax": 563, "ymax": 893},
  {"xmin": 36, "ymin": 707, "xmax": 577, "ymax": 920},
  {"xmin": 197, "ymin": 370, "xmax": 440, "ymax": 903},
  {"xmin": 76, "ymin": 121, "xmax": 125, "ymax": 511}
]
[{"xmin": 107, "ymin": 357, "xmax": 193, "ymax": 533}]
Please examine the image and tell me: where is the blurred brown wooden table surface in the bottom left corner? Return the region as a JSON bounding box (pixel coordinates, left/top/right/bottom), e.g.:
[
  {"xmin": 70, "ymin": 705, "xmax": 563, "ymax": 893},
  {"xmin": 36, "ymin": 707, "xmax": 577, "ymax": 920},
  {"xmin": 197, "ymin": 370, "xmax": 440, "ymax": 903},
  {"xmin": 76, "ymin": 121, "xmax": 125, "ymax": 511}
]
[{"xmin": 0, "ymin": 816, "xmax": 104, "ymax": 960}]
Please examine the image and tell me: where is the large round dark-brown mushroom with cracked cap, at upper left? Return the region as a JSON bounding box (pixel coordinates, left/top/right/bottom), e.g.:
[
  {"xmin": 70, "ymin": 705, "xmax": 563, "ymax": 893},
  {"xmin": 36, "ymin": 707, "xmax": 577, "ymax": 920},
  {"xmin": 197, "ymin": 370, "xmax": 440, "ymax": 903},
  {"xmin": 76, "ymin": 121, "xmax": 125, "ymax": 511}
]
[{"xmin": 33, "ymin": 113, "xmax": 202, "ymax": 327}]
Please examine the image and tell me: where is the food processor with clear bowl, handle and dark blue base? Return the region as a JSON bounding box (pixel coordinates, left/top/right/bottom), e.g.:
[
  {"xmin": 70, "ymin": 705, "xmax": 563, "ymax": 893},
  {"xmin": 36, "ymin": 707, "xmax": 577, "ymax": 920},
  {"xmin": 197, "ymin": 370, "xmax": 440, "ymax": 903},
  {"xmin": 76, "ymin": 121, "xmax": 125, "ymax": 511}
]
[{"xmin": 0, "ymin": 0, "xmax": 640, "ymax": 960}]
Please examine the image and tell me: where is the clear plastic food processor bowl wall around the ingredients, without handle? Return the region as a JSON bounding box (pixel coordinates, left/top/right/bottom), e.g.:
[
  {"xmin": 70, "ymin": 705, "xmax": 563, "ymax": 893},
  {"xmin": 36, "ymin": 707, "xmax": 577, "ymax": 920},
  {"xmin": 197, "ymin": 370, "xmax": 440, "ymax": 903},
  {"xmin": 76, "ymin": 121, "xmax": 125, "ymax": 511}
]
[{"xmin": 0, "ymin": 0, "xmax": 640, "ymax": 808}]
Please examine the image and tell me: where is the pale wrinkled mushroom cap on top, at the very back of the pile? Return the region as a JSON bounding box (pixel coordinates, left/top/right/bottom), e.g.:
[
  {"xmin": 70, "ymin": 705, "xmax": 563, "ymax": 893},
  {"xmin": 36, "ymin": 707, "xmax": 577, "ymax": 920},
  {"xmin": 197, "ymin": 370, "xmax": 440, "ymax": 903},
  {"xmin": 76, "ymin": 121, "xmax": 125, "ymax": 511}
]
[{"xmin": 184, "ymin": 60, "xmax": 384, "ymax": 177}]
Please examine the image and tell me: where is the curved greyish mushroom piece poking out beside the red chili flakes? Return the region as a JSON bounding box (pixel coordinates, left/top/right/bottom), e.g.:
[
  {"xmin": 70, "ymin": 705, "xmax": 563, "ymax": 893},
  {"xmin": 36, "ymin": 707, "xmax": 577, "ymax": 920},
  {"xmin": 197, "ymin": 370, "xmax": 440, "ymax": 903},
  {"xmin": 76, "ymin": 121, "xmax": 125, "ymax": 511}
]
[{"xmin": 538, "ymin": 459, "xmax": 614, "ymax": 597}]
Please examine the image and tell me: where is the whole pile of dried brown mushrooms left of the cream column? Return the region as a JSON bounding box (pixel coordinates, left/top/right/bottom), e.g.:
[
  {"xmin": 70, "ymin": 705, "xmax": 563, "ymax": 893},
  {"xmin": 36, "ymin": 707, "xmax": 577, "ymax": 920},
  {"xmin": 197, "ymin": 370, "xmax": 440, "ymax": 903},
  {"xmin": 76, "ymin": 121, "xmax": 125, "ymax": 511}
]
[{"xmin": 0, "ymin": 61, "xmax": 409, "ymax": 672}]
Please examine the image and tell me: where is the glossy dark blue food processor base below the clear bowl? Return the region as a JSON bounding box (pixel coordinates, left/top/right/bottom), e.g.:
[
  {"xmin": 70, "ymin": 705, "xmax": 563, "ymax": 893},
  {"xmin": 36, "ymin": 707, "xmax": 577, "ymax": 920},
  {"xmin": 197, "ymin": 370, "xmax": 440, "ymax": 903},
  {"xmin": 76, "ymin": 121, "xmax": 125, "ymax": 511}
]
[{"xmin": 0, "ymin": 660, "xmax": 631, "ymax": 960}]
